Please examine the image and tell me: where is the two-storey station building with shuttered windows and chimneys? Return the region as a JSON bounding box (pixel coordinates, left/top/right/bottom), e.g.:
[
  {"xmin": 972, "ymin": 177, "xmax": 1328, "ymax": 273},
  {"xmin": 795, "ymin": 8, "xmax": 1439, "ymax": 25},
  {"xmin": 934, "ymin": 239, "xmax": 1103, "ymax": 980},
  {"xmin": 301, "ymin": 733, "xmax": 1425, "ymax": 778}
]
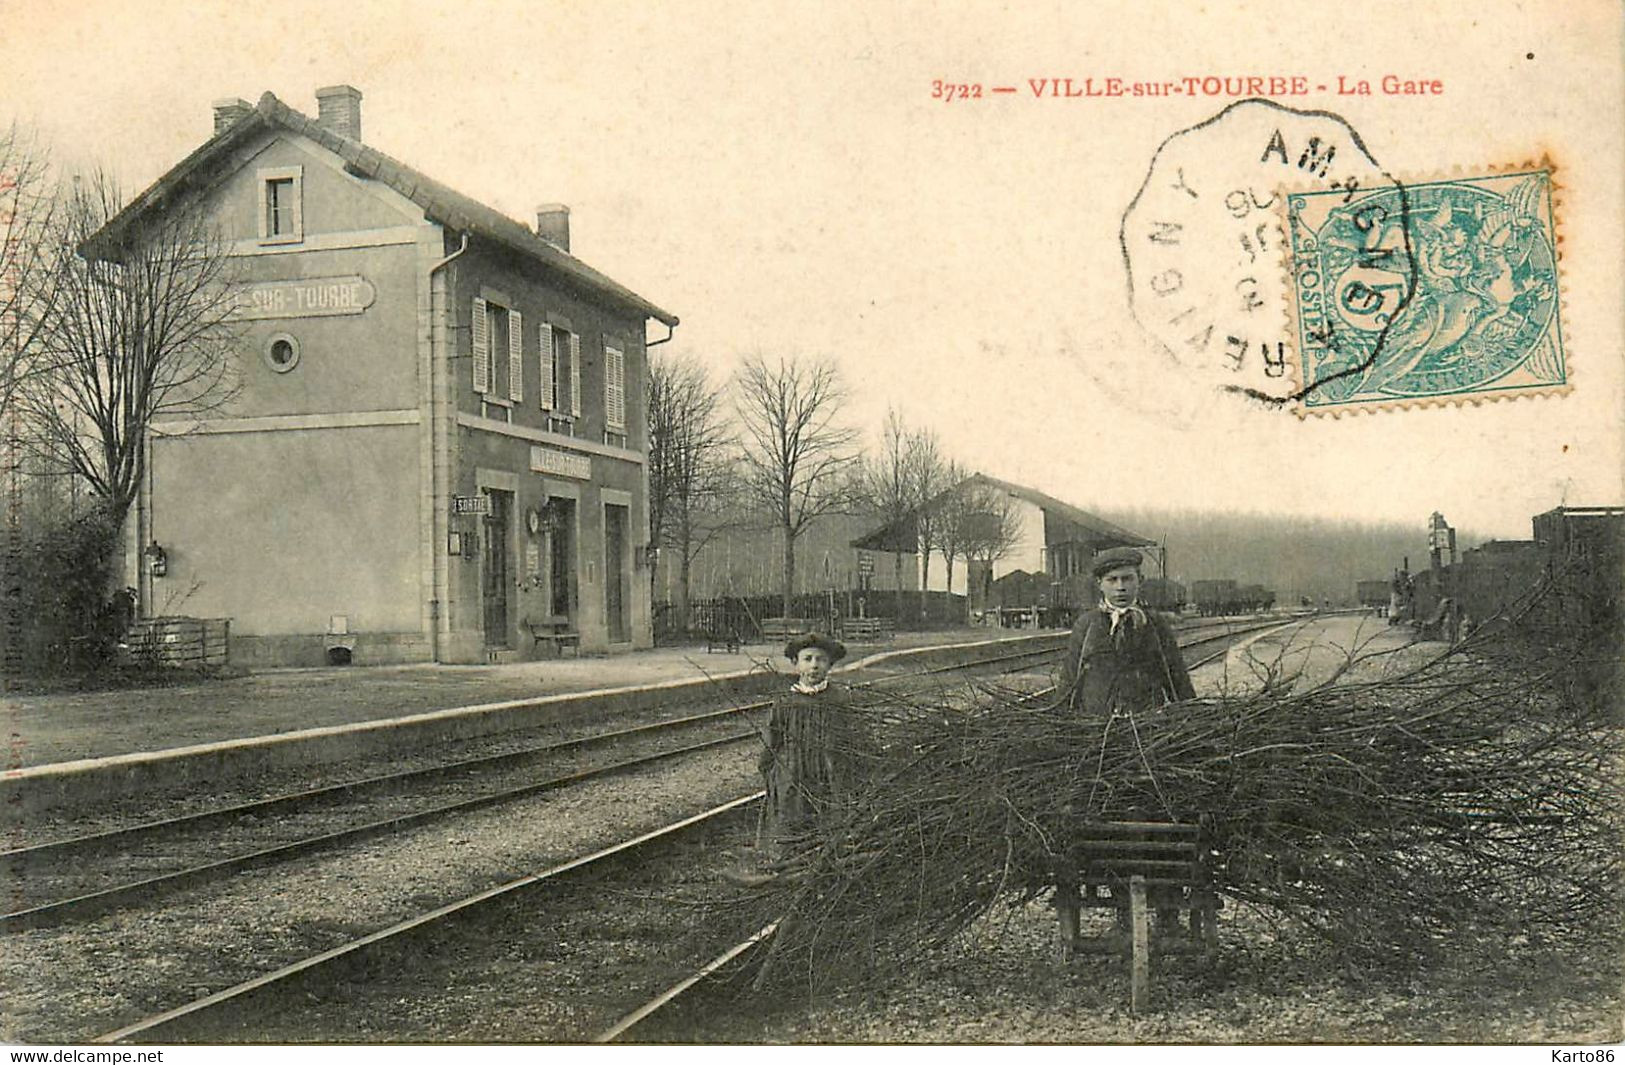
[{"xmin": 92, "ymin": 86, "xmax": 678, "ymax": 665}]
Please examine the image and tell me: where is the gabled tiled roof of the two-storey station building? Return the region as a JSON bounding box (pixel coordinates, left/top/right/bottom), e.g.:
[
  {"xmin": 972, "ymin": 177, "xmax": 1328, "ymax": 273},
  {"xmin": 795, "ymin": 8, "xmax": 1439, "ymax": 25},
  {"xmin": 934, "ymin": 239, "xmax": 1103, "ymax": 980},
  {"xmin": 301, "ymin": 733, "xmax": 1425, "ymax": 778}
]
[{"xmin": 81, "ymin": 93, "xmax": 678, "ymax": 327}]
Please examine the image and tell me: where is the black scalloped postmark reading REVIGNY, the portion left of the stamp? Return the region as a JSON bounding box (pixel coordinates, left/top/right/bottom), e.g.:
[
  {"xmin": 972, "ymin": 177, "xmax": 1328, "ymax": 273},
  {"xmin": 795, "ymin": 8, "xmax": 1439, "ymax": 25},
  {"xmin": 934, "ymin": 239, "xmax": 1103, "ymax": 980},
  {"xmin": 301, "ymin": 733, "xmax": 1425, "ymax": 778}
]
[{"xmin": 1120, "ymin": 99, "xmax": 1412, "ymax": 406}]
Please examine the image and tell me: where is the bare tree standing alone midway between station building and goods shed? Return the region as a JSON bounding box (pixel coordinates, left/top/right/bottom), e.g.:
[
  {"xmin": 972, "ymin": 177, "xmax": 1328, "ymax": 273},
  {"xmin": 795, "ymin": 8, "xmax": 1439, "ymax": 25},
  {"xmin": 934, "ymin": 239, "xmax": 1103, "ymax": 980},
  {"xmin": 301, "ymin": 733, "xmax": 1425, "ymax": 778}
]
[{"xmin": 735, "ymin": 354, "xmax": 856, "ymax": 616}]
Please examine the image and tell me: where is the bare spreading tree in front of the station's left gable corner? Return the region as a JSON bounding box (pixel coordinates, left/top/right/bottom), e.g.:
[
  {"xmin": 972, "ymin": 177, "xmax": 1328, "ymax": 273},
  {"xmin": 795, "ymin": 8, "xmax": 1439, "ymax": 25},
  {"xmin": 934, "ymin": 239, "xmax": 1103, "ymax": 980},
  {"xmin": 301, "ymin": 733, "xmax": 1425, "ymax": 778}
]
[{"xmin": 18, "ymin": 172, "xmax": 237, "ymax": 522}]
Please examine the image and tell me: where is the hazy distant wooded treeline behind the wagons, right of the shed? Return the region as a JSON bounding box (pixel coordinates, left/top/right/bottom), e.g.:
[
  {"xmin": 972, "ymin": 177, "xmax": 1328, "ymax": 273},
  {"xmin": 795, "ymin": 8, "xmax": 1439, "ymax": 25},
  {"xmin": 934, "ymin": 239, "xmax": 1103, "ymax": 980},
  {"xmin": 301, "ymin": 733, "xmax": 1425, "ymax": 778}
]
[{"xmin": 1099, "ymin": 507, "xmax": 1479, "ymax": 605}]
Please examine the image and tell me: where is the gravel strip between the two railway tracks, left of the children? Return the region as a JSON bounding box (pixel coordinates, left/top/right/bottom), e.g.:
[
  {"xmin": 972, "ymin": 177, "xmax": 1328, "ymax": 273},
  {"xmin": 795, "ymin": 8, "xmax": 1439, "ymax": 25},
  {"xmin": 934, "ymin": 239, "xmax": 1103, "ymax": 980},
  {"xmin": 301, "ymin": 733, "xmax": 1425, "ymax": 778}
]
[{"xmin": 0, "ymin": 748, "xmax": 759, "ymax": 1042}]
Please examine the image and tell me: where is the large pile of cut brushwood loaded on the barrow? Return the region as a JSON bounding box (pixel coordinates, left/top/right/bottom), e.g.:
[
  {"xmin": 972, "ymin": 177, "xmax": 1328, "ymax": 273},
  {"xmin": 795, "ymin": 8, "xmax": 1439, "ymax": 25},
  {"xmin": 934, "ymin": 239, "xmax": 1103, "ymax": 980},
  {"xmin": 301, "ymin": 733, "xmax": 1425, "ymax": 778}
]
[{"xmin": 736, "ymin": 598, "xmax": 1622, "ymax": 990}]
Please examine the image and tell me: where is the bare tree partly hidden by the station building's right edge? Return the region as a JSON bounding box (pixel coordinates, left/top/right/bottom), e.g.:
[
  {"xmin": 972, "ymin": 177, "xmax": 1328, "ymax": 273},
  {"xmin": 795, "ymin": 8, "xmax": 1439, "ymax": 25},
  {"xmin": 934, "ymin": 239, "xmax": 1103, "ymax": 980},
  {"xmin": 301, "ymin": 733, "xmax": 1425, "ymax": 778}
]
[{"xmin": 648, "ymin": 354, "xmax": 733, "ymax": 631}]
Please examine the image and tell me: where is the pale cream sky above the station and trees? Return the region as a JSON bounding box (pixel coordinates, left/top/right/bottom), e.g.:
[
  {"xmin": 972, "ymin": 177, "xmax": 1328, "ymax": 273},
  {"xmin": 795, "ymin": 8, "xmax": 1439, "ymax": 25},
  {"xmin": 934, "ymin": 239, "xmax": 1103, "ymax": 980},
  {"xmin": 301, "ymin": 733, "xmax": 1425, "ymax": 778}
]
[{"xmin": 0, "ymin": 0, "xmax": 1625, "ymax": 537}]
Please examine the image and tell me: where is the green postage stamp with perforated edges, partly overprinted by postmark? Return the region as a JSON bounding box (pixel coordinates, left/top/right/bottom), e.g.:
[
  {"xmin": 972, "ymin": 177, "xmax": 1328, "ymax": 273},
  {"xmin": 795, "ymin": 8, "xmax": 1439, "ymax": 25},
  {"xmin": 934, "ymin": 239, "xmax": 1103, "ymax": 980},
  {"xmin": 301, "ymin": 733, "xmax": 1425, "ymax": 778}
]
[{"xmin": 1287, "ymin": 167, "xmax": 1568, "ymax": 413}]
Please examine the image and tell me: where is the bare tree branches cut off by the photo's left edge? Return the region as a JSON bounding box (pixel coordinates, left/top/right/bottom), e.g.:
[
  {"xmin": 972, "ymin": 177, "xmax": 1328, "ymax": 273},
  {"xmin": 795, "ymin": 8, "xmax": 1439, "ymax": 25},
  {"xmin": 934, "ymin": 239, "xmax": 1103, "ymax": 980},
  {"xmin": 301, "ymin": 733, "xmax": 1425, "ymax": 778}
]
[{"xmin": 0, "ymin": 125, "xmax": 57, "ymax": 419}]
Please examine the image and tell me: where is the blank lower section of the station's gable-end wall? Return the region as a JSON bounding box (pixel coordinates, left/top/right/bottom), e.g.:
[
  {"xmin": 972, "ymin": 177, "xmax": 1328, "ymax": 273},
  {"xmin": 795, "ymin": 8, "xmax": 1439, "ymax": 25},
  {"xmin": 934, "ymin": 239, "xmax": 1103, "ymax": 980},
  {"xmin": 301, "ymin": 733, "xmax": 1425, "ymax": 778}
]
[{"xmin": 148, "ymin": 424, "xmax": 426, "ymax": 665}]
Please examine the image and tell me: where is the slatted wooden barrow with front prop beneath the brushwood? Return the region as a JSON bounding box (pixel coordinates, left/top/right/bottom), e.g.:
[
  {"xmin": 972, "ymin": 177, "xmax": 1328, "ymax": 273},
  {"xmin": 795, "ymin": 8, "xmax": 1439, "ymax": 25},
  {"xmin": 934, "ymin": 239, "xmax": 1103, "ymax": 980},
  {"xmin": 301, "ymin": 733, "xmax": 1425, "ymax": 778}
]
[{"xmin": 1055, "ymin": 821, "xmax": 1220, "ymax": 1010}]
